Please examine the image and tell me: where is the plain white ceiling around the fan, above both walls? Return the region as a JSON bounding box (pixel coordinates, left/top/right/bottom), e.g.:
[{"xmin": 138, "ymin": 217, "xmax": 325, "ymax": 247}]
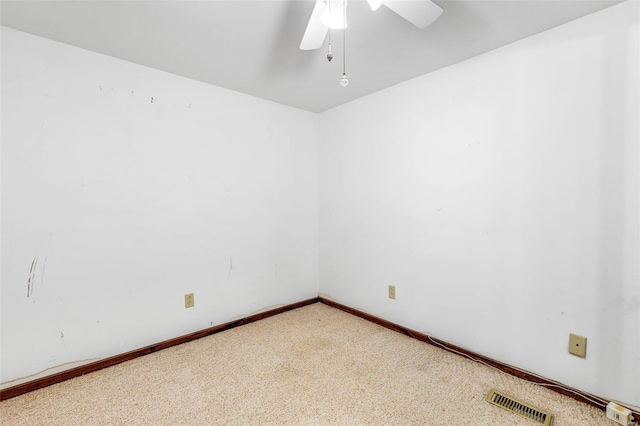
[{"xmin": 0, "ymin": 0, "xmax": 621, "ymax": 112}]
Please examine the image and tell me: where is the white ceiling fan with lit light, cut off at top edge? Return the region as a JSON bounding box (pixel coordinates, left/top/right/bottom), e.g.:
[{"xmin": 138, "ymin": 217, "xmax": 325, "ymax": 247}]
[{"xmin": 300, "ymin": 0, "xmax": 442, "ymax": 50}]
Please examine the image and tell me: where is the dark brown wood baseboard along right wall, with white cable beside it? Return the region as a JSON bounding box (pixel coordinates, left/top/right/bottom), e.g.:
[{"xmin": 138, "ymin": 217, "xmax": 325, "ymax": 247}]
[{"xmin": 319, "ymin": 297, "xmax": 640, "ymax": 422}]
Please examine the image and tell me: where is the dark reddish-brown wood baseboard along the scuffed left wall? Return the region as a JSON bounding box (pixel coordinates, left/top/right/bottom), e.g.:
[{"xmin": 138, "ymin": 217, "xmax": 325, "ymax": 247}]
[{"xmin": 0, "ymin": 297, "xmax": 320, "ymax": 401}]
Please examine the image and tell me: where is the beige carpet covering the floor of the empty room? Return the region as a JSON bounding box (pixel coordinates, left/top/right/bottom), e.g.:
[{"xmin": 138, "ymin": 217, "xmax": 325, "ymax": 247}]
[{"xmin": 0, "ymin": 303, "xmax": 611, "ymax": 426}]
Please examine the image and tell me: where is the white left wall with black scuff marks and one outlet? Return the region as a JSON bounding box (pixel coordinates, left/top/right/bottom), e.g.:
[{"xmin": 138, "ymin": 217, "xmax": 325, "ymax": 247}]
[{"xmin": 1, "ymin": 28, "xmax": 318, "ymax": 386}]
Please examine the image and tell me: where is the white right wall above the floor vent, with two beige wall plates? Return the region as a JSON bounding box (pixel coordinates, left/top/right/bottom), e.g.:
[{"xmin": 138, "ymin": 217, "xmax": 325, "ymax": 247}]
[{"xmin": 319, "ymin": 2, "xmax": 640, "ymax": 405}]
